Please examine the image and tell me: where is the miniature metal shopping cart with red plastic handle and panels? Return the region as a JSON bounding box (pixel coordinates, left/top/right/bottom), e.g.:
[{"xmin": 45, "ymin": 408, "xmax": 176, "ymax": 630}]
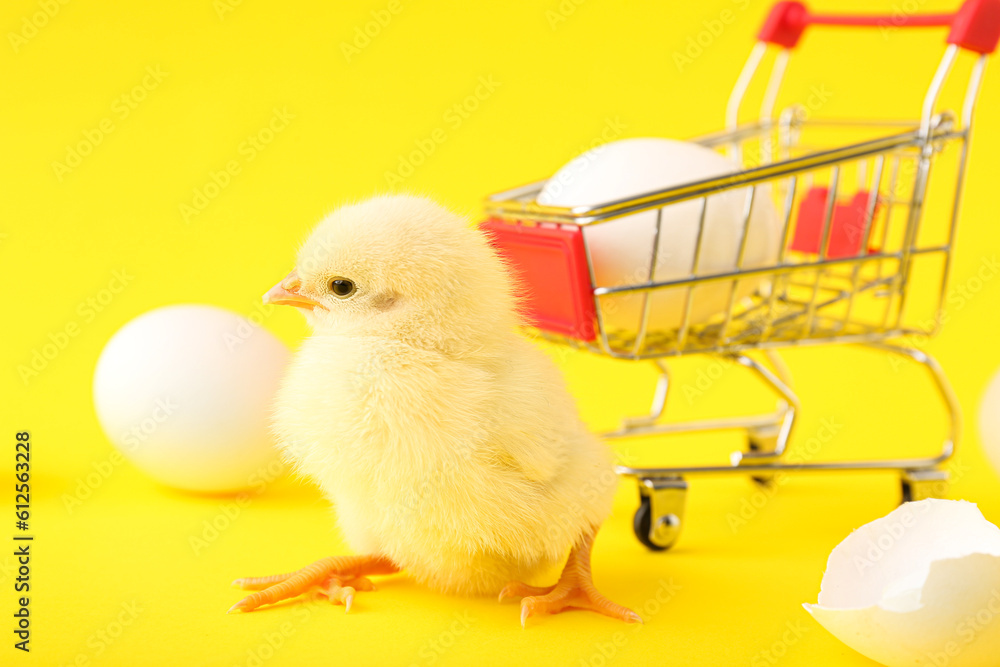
[{"xmin": 482, "ymin": 0, "xmax": 1000, "ymax": 550}]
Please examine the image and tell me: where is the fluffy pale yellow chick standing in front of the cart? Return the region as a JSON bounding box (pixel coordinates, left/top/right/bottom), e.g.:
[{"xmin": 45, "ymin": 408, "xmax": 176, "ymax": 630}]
[{"xmin": 230, "ymin": 196, "xmax": 641, "ymax": 626}]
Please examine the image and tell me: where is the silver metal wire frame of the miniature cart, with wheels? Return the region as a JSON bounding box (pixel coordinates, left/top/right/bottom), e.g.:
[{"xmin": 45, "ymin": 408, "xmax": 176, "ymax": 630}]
[{"xmin": 485, "ymin": 1, "xmax": 997, "ymax": 550}]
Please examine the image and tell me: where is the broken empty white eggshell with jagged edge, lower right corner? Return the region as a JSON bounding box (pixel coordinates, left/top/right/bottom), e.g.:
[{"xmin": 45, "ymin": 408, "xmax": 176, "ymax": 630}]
[{"xmin": 804, "ymin": 499, "xmax": 1000, "ymax": 667}]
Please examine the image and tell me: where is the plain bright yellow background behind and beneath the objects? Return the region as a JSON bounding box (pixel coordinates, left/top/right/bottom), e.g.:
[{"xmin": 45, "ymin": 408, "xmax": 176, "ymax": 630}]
[{"xmin": 0, "ymin": 0, "xmax": 1000, "ymax": 666}]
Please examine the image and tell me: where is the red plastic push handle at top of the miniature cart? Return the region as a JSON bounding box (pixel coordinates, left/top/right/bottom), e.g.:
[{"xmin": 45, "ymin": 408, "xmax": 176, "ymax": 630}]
[{"xmin": 757, "ymin": 0, "xmax": 1000, "ymax": 54}]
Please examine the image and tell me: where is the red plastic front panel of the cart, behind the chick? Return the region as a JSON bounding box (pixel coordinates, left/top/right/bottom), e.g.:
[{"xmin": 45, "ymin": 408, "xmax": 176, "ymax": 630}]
[{"xmin": 479, "ymin": 219, "xmax": 595, "ymax": 341}]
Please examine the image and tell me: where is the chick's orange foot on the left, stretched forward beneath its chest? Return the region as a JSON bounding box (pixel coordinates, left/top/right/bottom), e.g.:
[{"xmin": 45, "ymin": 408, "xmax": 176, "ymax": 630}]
[{"xmin": 229, "ymin": 556, "xmax": 399, "ymax": 613}]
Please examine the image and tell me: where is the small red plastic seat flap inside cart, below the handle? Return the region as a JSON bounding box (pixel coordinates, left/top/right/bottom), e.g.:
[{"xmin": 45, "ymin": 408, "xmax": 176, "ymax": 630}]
[{"xmin": 789, "ymin": 187, "xmax": 877, "ymax": 259}]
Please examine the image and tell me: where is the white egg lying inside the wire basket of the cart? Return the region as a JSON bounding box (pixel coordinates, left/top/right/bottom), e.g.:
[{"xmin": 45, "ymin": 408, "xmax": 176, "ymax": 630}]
[{"xmin": 538, "ymin": 138, "xmax": 780, "ymax": 332}]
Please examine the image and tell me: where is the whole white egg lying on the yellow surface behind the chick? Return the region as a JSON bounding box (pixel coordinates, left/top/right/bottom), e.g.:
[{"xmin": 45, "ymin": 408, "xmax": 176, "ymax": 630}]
[{"xmin": 94, "ymin": 305, "xmax": 289, "ymax": 492}]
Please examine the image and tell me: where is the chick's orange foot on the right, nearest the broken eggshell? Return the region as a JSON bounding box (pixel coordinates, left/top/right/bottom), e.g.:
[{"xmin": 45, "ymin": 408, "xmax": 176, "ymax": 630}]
[{"xmin": 500, "ymin": 530, "xmax": 642, "ymax": 627}]
